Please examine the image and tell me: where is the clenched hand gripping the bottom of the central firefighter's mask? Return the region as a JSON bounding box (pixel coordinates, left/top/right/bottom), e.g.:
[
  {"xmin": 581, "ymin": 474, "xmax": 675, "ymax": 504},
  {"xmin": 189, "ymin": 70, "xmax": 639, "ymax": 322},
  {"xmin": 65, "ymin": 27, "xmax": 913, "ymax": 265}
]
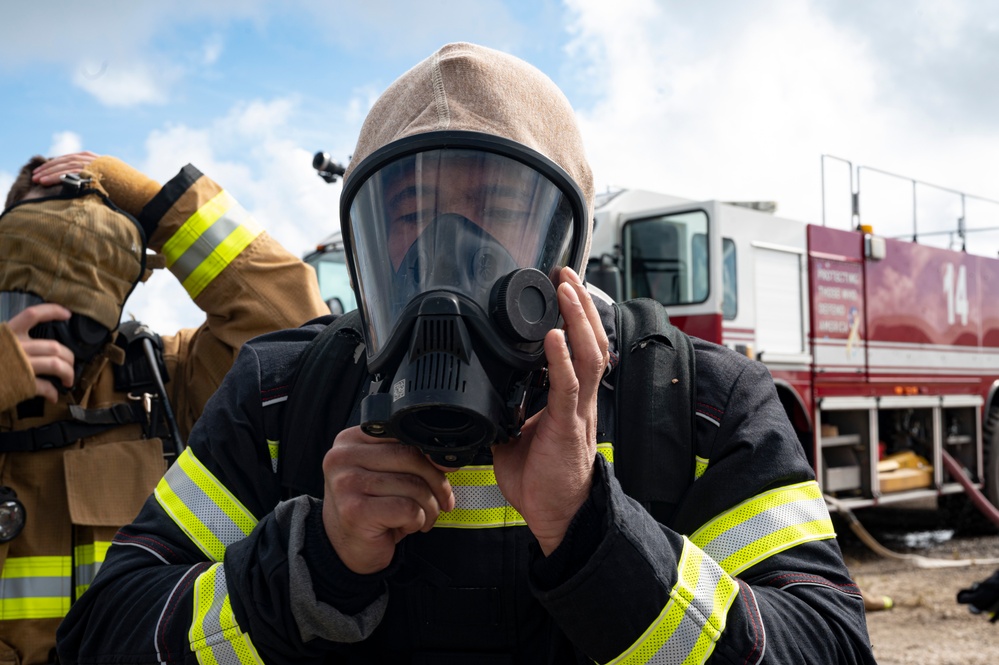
[{"xmin": 323, "ymin": 427, "xmax": 454, "ymax": 575}]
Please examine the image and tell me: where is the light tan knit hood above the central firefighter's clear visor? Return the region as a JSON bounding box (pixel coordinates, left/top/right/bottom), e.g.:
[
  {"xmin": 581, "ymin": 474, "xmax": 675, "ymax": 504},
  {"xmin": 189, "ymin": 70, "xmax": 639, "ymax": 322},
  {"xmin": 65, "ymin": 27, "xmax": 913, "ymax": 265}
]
[{"xmin": 344, "ymin": 43, "xmax": 593, "ymax": 268}]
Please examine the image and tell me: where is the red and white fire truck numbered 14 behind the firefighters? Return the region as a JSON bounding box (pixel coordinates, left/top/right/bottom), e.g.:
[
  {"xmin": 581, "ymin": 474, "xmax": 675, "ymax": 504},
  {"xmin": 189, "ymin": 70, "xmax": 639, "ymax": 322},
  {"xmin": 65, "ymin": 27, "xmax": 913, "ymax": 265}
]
[{"xmin": 305, "ymin": 154, "xmax": 999, "ymax": 508}]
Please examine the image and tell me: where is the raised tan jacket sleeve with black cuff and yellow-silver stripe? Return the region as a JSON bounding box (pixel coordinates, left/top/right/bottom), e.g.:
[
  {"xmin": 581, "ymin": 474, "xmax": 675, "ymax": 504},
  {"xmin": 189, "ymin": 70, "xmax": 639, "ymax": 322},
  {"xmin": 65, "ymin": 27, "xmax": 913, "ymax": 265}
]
[{"xmin": 133, "ymin": 165, "xmax": 329, "ymax": 436}]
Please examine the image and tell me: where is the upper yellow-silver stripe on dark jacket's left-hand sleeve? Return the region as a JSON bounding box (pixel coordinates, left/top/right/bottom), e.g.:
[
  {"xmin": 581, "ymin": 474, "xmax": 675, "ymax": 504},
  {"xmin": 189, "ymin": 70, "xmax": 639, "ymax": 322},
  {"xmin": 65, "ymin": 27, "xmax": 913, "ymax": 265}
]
[{"xmin": 153, "ymin": 448, "xmax": 257, "ymax": 561}]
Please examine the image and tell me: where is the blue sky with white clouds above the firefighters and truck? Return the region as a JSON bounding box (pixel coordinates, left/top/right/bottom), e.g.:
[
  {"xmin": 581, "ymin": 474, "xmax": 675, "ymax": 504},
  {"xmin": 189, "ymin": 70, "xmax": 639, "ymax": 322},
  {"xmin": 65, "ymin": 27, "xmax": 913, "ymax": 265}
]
[{"xmin": 0, "ymin": 0, "xmax": 999, "ymax": 334}]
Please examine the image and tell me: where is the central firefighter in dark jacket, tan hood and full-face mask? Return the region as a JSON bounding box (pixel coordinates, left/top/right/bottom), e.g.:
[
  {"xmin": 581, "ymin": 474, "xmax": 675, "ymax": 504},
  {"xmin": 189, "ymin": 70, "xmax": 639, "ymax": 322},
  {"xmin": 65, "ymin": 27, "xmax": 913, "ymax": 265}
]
[{"xmin": 59, "ymin": 43, "xmax": 874, "ymax": 663}]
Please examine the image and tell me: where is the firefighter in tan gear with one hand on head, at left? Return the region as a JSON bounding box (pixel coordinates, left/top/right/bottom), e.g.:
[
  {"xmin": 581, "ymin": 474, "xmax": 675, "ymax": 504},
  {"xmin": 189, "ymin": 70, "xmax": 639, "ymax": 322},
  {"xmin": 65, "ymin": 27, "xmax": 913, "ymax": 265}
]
[{"xmin": 0, "ymin": 153, "xmax": 328, "ymax": 665}]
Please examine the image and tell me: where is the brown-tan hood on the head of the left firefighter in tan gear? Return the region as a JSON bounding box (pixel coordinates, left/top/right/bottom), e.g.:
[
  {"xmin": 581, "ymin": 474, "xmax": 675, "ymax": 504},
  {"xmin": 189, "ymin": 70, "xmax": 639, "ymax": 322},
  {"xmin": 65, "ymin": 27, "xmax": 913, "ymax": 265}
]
[{"xmin": 0, "ymin": 171, "xmax": 145, "ymax": 330}]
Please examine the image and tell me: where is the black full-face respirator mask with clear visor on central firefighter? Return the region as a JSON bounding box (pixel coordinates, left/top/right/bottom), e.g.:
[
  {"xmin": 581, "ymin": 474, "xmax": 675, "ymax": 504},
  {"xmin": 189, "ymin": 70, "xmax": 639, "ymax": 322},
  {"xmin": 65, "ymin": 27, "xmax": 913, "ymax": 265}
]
[{"xmin": 340, "ymin": 132, "xmax": 586, "ymax": 467}]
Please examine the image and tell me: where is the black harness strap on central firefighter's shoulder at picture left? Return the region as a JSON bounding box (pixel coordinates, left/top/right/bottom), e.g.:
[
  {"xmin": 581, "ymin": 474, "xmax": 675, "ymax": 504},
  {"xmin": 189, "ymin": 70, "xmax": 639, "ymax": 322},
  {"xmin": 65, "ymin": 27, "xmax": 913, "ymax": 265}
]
[{"xmin": 278, "ymin": 310, "xmax": 368, "ymax": 496}]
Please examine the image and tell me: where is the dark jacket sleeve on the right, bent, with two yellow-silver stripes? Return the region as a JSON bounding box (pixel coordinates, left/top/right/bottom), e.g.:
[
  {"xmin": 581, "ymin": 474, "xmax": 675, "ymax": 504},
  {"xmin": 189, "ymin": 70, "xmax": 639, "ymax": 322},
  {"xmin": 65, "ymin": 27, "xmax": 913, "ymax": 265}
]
[{"xmin": 532, "ymin": 343, "xmax": 874, "ymax": 664}]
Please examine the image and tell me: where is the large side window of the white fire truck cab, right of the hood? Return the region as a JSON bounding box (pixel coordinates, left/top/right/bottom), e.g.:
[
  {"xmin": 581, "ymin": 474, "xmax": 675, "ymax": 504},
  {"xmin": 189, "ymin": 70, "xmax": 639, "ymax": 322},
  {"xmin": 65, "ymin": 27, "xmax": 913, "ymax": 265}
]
[{"xmin": 623, "ymin": 210, "xmax": 708, "ymax": 305}]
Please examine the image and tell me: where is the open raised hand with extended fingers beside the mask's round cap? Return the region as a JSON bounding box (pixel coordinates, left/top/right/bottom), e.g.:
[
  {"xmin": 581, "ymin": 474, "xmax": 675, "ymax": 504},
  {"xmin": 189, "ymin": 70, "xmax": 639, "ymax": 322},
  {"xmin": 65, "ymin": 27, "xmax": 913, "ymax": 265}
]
[{"xmin": 493, "ymin": 268, "xmax": 609, "ymax": 555}]
